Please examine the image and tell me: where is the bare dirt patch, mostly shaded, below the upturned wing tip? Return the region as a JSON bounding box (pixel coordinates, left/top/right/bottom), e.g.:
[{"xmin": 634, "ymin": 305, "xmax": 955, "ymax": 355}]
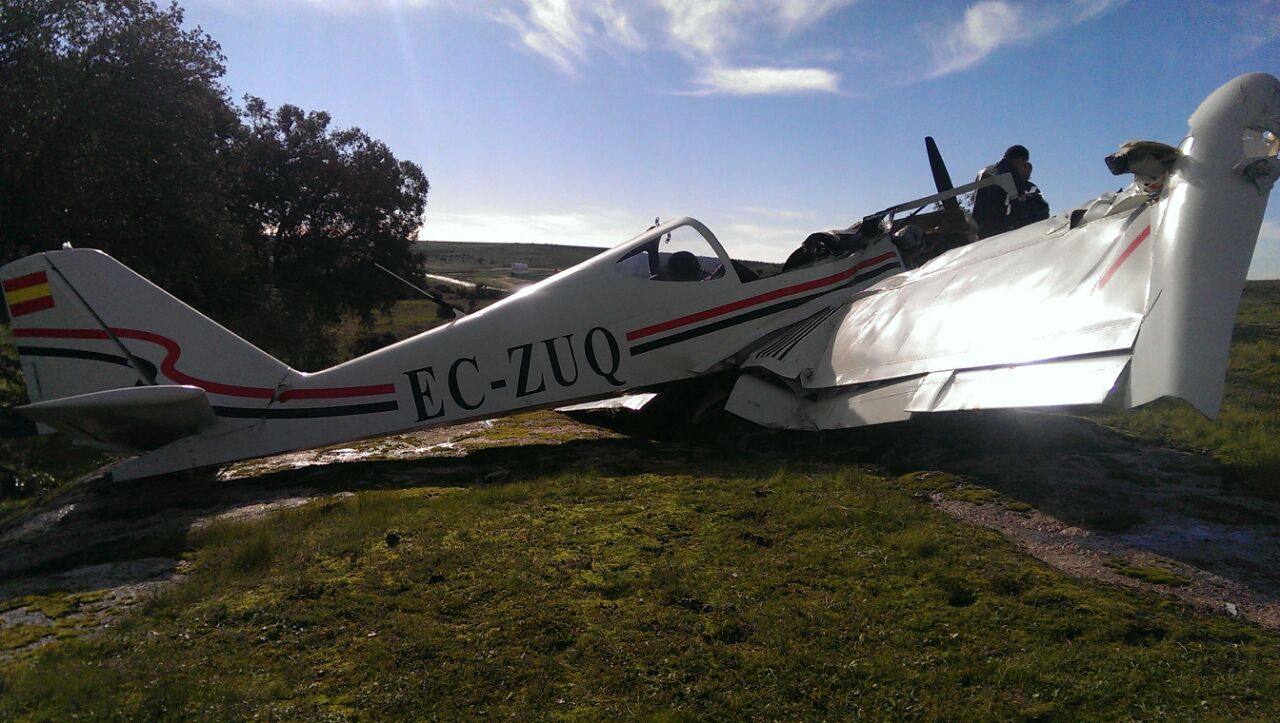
[{"xmin": 884, "ymin": 413, "xmax": 1280, "ymax": 630}]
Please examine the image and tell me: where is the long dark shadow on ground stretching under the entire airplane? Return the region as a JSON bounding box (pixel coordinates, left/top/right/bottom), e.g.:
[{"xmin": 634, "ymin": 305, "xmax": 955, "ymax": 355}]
[{"xmin": 0, "ymin": 412, "xmax": 1280, "ymax": 619}]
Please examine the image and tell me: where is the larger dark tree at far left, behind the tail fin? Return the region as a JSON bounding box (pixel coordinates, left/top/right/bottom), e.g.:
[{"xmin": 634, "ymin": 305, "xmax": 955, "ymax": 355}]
[{"xmin": 0, "ymin": 0, "xmax": 260, "ymax": 315}]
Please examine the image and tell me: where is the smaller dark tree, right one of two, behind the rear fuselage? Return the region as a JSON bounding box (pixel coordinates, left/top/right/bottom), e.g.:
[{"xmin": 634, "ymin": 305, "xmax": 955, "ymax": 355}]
[{"xmin": 237, "ymin": 97, "xmax": 429, "ymax": 324}]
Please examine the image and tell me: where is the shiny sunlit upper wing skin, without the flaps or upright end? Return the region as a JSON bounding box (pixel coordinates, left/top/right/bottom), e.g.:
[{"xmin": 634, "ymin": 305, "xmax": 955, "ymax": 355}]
[{"xmin": 803, "ymin": 203, "xmax": 1151, "ymax": 388}]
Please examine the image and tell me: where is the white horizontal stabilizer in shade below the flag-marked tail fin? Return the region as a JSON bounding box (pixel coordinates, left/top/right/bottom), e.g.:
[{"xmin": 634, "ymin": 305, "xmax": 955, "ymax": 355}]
[{"xmin": 18, "ymin": 384, "xmax": 215, "ymax": 450}]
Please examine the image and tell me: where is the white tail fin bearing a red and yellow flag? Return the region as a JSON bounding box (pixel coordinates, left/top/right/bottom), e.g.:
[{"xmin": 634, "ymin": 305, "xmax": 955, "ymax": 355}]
[{"xmin": 0, "ymin": 248, "xmax": 289, "ymax": 439}]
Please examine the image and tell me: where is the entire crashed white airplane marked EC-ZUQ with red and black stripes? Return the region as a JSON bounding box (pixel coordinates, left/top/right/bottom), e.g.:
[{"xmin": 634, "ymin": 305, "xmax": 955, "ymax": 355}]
[{"xmin": 0, "ymin": 73, "xmax": 1280, "ymax": 479}]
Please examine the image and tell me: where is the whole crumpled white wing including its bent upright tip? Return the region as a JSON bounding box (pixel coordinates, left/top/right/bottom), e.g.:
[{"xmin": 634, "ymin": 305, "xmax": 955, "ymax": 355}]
[{"xmin": 726, "ymin": 73, "xmax": 1280, "ymax": 429}]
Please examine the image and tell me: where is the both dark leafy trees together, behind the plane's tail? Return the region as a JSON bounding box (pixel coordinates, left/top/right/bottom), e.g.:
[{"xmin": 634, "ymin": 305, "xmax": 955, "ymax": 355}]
[{"xmin": 0, "ymin": 0, "xmax": 428, "ymax": 365}]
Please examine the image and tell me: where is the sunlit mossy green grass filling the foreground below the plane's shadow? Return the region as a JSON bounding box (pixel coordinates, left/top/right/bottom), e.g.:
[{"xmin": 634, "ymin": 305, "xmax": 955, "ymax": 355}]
[{"xmin": 0, "ymin": 450, "xmax": 1280, "ymax": 719}]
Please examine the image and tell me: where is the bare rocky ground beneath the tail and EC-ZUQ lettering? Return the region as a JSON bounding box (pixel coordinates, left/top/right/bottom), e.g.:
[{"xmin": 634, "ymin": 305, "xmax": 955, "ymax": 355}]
[{"xmin": 0, "ymin": 413, "xmax": 629, "ymax": 656}]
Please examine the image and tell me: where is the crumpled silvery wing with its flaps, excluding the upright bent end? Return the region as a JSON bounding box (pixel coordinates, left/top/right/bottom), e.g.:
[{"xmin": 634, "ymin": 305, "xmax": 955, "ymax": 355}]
[{"xmin": 727, "ymin": 206, "xmax": 1153, "ymax": 429}]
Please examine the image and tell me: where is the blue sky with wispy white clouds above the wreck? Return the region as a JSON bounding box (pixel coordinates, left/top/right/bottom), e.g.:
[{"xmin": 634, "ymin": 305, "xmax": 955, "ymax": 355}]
[{"xmin": 182, "ymin": 0, "xmax": 1280, "ymax": 278}]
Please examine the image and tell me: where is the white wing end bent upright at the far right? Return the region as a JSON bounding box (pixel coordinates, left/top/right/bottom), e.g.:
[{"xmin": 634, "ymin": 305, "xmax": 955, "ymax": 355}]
[{"xmin": 1130, "ymin": 73, "xmax": 1280, "ymax": 417}]
